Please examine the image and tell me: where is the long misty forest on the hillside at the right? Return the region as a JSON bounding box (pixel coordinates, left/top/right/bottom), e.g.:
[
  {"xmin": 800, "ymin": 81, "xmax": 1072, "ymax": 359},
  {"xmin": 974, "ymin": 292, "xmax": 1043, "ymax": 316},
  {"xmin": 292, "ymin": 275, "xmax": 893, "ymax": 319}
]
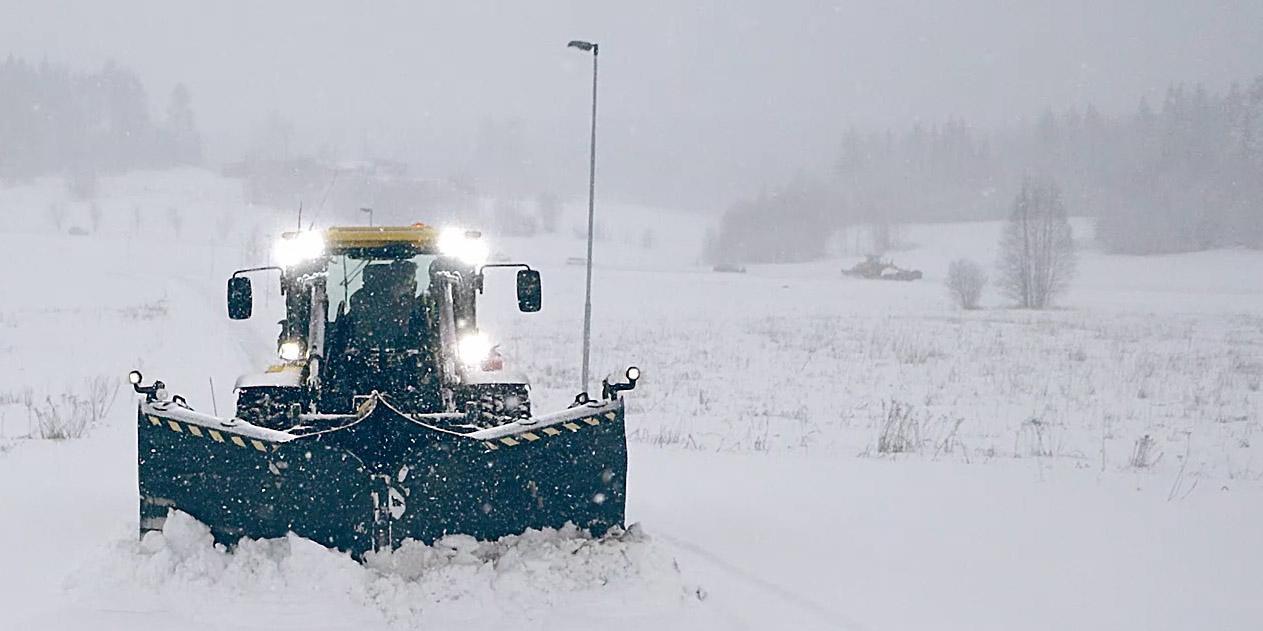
[{"xmin": 709, "ymin": 76, "xmax": 1263, "ymax": 261}]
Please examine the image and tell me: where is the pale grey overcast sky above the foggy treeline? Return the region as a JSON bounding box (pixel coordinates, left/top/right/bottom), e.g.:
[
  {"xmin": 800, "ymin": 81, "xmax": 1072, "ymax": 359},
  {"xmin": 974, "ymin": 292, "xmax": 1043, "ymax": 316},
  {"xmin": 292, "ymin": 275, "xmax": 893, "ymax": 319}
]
[{"xmin": 0, "ymin": 0, "xmax": 1263, "ymax": 204}]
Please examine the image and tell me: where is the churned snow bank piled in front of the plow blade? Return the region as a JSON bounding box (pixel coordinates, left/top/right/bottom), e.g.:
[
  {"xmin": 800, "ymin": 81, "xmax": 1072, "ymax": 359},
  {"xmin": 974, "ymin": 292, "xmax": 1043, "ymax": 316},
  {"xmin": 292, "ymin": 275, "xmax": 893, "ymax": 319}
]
[{"xmin": 67, "ymin": 512, "xmax": 698, "ymax": 628}]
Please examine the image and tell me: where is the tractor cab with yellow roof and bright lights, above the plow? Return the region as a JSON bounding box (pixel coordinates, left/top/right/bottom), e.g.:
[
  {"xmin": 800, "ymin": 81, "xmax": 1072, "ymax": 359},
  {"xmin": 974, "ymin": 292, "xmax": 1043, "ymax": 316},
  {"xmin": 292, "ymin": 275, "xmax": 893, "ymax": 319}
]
[{"xmin": 229, "ymin": 223, "xmax": 541, "ymax": 423}]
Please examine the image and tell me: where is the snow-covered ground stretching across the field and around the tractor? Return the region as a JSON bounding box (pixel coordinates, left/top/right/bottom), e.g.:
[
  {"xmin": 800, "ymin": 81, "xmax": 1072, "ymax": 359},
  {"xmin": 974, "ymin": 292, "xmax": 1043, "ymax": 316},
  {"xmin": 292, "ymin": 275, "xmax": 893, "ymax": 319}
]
[{"xmin": 0, "ymin": 170, "xmax": 1263, "ymax": 630}]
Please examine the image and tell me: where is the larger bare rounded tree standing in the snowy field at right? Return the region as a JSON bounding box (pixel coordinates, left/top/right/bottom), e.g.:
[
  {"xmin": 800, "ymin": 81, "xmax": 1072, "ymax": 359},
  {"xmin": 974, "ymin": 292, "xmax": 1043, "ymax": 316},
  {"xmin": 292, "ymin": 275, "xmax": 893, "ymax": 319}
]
[{"xmin": 999, "ymin": 179, "xmax": 1075, "ymax": 309}]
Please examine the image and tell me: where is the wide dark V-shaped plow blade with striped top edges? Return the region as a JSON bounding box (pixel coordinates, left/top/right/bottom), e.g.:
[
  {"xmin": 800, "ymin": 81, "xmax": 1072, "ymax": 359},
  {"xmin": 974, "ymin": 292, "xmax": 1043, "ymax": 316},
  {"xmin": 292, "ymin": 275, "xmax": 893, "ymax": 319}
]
[{"xmin": 138, "ymin": 396, "xmax": 626, "ymax": 558}]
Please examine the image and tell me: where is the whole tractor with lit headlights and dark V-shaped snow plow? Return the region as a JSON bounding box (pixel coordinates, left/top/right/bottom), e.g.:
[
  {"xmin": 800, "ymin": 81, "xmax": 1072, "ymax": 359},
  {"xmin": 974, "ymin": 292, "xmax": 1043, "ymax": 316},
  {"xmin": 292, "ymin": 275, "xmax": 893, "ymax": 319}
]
[{"xmin": 130, "ymin": 223, "xmax": 640, "ymax": 559}]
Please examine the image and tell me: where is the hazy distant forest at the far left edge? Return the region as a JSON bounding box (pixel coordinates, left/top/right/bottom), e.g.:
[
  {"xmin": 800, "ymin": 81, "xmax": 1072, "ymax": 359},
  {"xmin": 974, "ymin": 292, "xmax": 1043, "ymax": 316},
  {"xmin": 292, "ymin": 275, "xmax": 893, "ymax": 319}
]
[{"xmin": 0, "ymin": 56, "xmax": 202, "ymax": 186}]
